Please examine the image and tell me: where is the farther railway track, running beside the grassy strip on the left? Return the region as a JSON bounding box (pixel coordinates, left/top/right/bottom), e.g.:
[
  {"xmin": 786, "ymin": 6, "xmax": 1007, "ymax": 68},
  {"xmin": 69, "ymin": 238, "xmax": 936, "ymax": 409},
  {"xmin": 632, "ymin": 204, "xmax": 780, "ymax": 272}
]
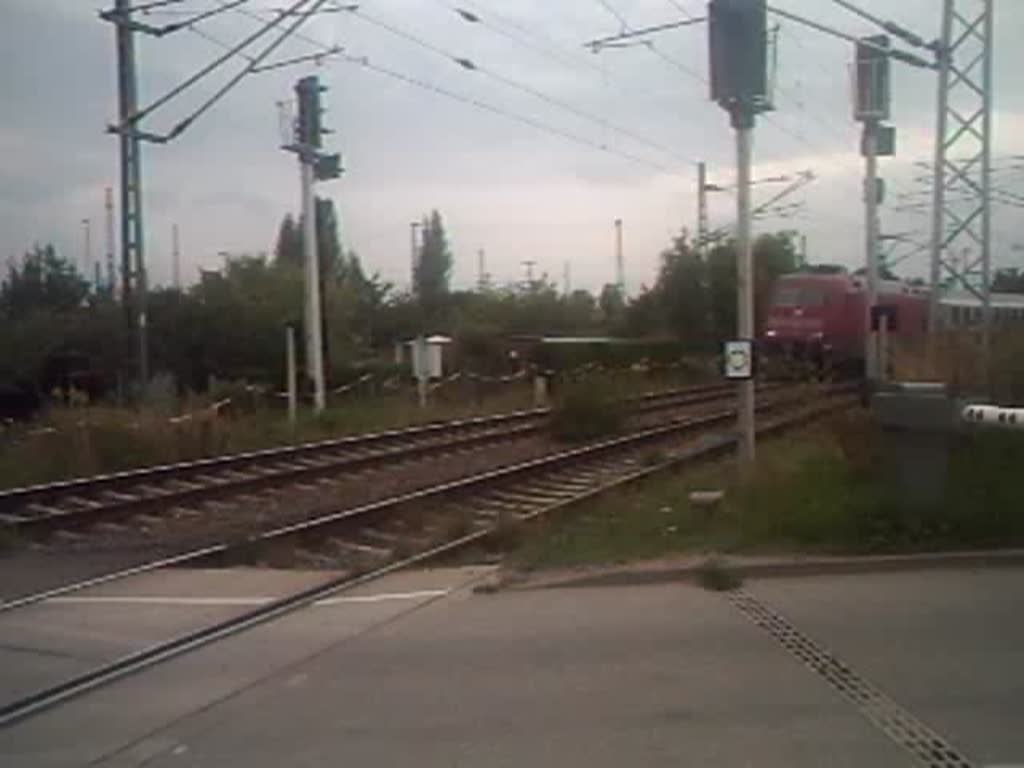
[{"xmin": 0, "ymin": 385, "xmax": 753, "ymax": 538}]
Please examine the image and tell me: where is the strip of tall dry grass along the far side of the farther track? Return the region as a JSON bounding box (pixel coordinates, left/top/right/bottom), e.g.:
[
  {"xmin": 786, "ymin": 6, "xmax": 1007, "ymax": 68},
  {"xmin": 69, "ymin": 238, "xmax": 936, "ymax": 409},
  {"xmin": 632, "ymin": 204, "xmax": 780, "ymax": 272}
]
[{"xmin": 0, "ymin": 371, "xmax": 689, "ymax": 487}]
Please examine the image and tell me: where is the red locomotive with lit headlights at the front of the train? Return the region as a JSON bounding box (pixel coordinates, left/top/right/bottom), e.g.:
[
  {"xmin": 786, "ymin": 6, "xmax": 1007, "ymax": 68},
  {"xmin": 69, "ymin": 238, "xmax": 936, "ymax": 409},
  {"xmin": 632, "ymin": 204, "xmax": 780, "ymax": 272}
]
[{"xmin": 761, "ymin": 267, "xmax": 928, "ymax": 368}]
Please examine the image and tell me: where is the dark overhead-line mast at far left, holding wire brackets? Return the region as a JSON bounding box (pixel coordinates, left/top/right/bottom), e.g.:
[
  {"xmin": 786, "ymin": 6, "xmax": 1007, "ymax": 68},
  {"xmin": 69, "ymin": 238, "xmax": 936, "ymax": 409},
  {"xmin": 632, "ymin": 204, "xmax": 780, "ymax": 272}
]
[{"xmin": 101, "ymin": 0, "xmax": 150, "ymax": 393}]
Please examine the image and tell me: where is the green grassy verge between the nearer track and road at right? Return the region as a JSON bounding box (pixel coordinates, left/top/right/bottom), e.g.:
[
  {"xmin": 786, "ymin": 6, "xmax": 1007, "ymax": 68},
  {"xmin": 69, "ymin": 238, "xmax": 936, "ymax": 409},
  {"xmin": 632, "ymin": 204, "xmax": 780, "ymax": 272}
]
[{"xmin": 514, "ymin": 414, "xmax": 1024, "ymax": 567}]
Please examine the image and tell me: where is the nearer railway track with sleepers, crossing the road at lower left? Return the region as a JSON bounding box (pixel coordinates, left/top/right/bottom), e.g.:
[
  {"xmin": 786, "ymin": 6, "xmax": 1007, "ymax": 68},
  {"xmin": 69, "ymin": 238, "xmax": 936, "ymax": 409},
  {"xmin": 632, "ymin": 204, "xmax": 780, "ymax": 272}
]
[{"xmin": 0, "ymin": 387, "xmax": 855, "ymax": 727}]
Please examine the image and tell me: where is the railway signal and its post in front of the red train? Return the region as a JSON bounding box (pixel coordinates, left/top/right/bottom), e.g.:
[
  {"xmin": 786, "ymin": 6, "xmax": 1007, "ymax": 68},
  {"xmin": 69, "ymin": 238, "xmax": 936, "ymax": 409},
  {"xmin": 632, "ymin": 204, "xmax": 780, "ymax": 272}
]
[{"xmin": 853, "ymin": 35, "xmax": 894, "ymax": 382}]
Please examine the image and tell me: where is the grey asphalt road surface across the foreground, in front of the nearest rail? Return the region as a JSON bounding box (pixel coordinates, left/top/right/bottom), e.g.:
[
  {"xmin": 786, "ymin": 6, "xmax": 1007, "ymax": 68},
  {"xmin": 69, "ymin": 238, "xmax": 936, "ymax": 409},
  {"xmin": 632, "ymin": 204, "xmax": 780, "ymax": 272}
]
[{"xmin": 0, "ymin": 569, "xmax": 1024, "ymax": 768}]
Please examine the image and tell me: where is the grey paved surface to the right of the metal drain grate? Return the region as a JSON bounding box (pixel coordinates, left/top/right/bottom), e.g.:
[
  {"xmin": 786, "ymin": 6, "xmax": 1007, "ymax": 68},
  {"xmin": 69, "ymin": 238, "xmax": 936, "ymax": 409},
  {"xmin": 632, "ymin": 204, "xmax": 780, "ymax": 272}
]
[{"xmin": 749, "ymin": 569, "xmax": 1024, "ymax": 766}]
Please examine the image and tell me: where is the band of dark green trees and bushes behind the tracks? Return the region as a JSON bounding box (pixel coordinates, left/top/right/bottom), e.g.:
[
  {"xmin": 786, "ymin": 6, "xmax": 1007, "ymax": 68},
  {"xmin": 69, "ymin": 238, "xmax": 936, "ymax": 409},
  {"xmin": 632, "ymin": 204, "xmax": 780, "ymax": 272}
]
[{"xmin": 0, "ymin": 210, "xmax": 797, "ymax": 417}]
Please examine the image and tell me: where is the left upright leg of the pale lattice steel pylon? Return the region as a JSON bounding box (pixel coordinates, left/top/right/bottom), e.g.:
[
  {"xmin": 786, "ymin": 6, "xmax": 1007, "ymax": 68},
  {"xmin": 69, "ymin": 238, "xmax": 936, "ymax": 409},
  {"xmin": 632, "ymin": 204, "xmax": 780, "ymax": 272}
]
[{"xmin": 928, "ymin": 0, "xmax": 953, "ymax": 337}]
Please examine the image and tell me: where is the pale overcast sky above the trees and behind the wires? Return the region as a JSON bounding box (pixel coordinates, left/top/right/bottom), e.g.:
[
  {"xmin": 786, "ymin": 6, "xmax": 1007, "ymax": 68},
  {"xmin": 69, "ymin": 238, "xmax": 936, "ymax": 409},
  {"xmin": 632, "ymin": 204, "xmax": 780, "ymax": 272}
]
[{"xmin": 0, "ymin": 0, "xmax": 1024, "ymax": 291}]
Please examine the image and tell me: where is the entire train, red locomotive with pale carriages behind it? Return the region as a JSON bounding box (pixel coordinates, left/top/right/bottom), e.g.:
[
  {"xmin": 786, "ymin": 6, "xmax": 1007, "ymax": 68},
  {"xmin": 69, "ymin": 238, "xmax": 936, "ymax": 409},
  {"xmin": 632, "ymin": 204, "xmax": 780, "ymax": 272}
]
[{"xmin": 760, "ymin": 268, "xmax": 1024, "ymax": 367}]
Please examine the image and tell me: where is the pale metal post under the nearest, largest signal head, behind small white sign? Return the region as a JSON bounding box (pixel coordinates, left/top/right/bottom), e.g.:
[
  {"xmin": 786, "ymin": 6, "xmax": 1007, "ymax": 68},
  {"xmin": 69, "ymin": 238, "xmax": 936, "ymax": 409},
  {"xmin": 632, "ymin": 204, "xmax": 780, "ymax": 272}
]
[{"xmin": 733, "ymin": 121, "xmax": 755, "ymax": 465}]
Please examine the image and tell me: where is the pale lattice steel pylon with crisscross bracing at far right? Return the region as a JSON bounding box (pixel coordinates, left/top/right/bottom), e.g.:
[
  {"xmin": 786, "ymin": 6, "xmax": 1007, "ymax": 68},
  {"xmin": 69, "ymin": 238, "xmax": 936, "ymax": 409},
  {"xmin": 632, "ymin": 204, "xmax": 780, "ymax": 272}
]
[{"xmin": 929, "ymin": 0, "xmax": 993, "ymax": 346}]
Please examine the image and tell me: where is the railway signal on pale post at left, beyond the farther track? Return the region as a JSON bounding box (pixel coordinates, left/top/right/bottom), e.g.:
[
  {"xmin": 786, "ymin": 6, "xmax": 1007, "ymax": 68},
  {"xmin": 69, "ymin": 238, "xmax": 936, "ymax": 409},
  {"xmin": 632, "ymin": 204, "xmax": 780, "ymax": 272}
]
[{"xmin": 284, "ymin": 75, "xmax": 342, "ymax": 414}]
